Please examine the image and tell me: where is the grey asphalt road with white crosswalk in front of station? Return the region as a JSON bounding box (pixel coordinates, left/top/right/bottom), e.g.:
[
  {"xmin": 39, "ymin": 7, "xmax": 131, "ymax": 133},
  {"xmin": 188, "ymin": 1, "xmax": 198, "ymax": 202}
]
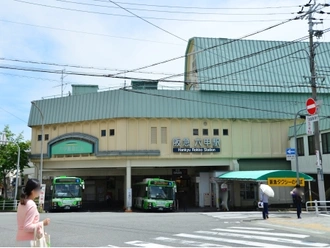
[{"xmin": 0, "ymin": 212, "xmax": 330, "ymax": 248}]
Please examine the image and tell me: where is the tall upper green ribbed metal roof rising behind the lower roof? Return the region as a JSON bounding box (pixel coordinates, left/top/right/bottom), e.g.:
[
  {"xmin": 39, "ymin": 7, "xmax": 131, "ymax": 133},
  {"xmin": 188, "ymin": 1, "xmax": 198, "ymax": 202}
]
[{"xmin": 185, "ymin": 37, "xmax": 330, "ymax": 93}]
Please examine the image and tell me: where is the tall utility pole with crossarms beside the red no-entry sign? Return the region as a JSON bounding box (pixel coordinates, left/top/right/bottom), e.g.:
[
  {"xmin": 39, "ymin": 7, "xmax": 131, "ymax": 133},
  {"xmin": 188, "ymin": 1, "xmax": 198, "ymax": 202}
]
[{"xmin": 308, "ymin": 0, "xmax": 326, "ymax": 205}]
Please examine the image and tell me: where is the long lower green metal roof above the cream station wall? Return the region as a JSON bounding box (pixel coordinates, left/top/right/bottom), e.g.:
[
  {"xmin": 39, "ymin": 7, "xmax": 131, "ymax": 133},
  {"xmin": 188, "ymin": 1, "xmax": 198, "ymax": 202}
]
[{"xmin": 28, "ymin": 90, "xmax": 330, "ymax": 126}]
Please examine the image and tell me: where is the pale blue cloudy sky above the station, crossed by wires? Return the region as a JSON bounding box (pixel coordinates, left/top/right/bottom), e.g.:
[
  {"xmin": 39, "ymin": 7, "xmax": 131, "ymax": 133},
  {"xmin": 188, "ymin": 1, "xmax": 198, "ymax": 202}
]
[{"xmin": 0, "ymin": 0, "xmax": 330, "ymax": 139}]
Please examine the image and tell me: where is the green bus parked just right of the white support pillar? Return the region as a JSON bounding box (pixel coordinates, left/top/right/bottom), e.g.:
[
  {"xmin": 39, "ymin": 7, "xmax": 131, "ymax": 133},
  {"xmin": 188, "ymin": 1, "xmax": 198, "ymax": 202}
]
[{"xmin": 132, "ymin": 178, "xmax": 176, "ymax": 211}]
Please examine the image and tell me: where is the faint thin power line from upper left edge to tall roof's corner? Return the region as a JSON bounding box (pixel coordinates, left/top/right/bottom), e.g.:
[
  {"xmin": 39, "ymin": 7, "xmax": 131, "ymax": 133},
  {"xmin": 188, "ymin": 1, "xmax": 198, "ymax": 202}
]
[{"xmin": 0, "ymin": 19, "xmax": 182, "ymax": 46}]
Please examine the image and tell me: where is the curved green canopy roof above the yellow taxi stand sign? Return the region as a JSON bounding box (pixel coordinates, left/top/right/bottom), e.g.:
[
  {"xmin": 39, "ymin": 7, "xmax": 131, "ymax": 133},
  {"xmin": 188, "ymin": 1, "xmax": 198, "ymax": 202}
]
[{"xmin": 219, "ymin": 170, "xmax": 314, "ymax": 181}]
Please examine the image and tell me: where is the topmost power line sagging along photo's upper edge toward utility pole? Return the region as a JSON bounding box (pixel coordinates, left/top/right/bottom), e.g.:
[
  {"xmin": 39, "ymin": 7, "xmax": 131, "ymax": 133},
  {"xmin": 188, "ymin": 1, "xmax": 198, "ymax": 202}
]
[{"xmin": 94, "ymin": 0, "xmax": 301, "ymax": 10}]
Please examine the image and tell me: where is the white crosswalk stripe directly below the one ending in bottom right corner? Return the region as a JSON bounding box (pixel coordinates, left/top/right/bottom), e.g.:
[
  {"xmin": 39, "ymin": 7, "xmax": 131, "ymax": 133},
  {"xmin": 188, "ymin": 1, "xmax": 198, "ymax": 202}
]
[{"xmin": 175, "ymin": 233, "xmax": 287, "ymax": 248}]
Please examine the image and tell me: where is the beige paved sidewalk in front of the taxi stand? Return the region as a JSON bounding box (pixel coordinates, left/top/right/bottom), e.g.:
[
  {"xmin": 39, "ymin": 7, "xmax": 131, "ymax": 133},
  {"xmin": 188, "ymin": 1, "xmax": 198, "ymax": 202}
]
[{"xmin": 267, "ymin": 211, "xmax": 330, "ymax": 235}]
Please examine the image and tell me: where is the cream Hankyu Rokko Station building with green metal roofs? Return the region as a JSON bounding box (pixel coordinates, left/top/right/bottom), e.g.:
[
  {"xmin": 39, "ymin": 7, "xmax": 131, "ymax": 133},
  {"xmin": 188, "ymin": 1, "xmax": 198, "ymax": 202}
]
[{"xmin": 28, "ymin": 38, "xmax": 330, "ymax": 207}]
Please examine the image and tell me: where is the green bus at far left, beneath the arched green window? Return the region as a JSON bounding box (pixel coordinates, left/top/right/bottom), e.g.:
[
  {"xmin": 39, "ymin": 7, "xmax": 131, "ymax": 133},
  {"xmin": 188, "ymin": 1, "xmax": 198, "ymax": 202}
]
[{"xmin": 50, "ymin": 176, "xmax": 85, "ymax": 210}]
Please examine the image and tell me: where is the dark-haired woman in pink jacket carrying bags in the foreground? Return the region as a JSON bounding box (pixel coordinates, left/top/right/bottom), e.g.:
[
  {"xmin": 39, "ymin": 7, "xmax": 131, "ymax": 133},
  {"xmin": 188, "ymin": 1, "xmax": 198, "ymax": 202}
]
[{"xmin": 16, "ymin": 179, "xmax": 50, "ymax": 247}]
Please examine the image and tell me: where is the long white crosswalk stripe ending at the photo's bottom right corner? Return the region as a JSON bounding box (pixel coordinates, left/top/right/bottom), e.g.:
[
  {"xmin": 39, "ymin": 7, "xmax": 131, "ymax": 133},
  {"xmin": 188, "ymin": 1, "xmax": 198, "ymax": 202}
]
[{"xmin": 195, "ymin": 231, "xmax": 328, "ymax": 247}]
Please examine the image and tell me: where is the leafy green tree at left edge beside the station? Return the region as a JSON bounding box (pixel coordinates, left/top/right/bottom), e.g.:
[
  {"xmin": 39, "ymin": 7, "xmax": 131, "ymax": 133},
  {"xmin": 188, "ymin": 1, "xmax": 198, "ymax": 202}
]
[{"xmin": 0, "ymin": 125, "xmax": 31, "ymax": 198}]
